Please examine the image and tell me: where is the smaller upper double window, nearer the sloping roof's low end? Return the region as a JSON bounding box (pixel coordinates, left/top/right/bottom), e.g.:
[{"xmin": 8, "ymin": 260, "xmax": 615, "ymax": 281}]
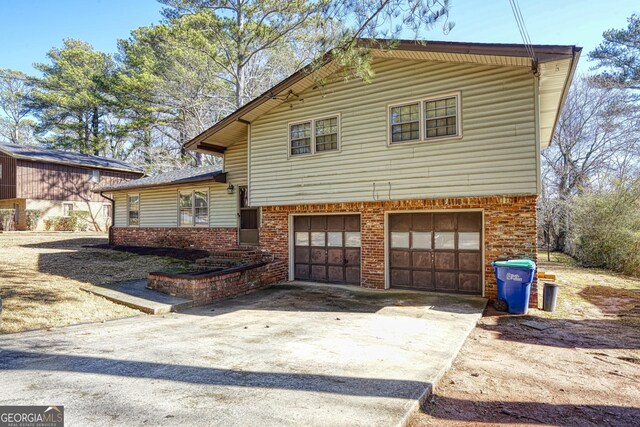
[{"xmin": 289, "ymin": 116, "xmax": 340, "ymax": 156}]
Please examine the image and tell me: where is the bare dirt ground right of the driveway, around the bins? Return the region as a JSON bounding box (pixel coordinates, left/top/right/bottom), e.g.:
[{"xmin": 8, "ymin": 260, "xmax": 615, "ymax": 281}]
[{"xmin": 410, "ymin": 254, "xmax": 640, "ymax": 427}]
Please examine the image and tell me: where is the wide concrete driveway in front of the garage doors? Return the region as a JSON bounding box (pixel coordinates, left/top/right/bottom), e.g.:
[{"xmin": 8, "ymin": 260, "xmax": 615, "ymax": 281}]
[{"xmin": 0, "ymin": 283, "xmax": 485, "ymax": 426}]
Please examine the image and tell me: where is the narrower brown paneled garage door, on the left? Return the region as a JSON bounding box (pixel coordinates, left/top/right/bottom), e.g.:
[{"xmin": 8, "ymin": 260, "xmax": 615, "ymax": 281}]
[{"xmin": 293, "ymin": 215, "xmax": 360, "ymax": 285}]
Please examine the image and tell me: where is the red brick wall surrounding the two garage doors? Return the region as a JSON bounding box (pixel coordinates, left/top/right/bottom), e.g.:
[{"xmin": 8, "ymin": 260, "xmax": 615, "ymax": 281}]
[{"xmin": 260, "ymin": 195, "xmax": 538, "ymax": 307}]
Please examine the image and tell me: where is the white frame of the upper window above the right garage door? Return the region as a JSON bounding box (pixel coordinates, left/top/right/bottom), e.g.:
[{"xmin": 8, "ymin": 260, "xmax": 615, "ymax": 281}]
[{"xmin": 387, "ymin": 91, "xmax": 462, "ymax": 147}]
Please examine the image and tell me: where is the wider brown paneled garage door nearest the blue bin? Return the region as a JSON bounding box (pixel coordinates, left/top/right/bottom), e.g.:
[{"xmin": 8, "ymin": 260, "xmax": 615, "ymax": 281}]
[{"xmin": 389, "ymin": 212, "xmax": 483, "ymax": 294}]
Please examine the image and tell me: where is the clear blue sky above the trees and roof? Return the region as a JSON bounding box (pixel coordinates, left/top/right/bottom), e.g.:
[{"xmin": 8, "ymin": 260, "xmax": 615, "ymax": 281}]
[{"xmin": 0, "ymin": 0, "xmax": 640, "ymax": 73}]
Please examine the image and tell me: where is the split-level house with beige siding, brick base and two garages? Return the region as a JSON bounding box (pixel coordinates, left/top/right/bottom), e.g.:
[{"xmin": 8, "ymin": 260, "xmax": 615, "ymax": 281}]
[{"xmin": 101, "ymin": 41, "xmax": 581, "ymax": 302}]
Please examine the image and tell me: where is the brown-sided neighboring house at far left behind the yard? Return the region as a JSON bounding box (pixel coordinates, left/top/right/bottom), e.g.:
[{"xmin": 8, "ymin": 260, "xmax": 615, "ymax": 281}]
[{"xmin": 0, "ymin": 143, "xmax": 144, "ymax": 231}]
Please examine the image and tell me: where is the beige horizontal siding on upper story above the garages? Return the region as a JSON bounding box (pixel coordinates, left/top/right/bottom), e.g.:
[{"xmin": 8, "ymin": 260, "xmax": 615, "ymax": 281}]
[{"xmin": 250, "ymin": 59, "xmax": 537, "ymax": 206}]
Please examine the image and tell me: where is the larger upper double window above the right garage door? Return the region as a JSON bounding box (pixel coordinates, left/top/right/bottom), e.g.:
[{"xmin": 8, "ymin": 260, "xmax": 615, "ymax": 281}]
[{"xmin": 389, "ymin": 93, "xmax": 461, "ymax": 144}]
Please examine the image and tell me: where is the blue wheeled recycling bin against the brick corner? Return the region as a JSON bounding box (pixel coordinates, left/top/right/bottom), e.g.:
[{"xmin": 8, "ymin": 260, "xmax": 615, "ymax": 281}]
[{"xmin": 491, "ymin": 259, "xmax": 536, "ymax": 314}]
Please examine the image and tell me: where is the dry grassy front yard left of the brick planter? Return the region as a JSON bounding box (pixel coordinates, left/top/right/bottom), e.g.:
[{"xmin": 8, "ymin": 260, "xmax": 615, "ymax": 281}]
[{"xmin": 0, "ymin": 232, "xmax": 186, "ymax": 333}]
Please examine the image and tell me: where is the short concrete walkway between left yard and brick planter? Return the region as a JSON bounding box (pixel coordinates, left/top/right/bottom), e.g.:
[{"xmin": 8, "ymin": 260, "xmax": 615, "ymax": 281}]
[{"xmin": 82, "ymin": 279, "xmax": 193, "ymax": 314}]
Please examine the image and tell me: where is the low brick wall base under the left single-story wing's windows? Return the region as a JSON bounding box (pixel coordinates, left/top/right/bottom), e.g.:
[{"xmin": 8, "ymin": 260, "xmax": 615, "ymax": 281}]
[{"xmin": 109, "ymin": 227, "xmax": 238, "ymax": 251}]
